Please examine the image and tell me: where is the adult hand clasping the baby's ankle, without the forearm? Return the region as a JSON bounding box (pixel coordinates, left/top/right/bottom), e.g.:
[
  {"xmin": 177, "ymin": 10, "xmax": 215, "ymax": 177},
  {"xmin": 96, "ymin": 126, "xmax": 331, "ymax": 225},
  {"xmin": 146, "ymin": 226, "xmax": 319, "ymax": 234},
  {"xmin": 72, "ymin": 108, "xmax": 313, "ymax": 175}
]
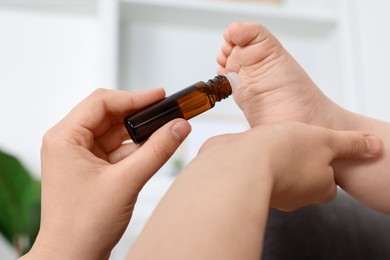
[{"xmin": 196, "ymin": 122, "xmax": 382, "ymax": 210}]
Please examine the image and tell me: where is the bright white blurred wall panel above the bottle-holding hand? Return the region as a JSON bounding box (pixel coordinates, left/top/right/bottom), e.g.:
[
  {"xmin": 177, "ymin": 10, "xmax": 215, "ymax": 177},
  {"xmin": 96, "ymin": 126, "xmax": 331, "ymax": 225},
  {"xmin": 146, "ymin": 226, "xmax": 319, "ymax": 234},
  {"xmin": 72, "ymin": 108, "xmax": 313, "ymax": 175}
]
[{"xmin": 0, "ymin": 5, "xmax": 97, "ymax": 259}]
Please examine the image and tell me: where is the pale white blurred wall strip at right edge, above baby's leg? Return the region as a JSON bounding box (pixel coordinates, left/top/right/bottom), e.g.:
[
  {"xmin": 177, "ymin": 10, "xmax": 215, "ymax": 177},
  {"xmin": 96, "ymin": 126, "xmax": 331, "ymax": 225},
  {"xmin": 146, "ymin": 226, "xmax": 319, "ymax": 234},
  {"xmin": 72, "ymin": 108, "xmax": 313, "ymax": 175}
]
[{"xmin": 355, "ymin": 0, "xmax": 390, "ymax": 121}]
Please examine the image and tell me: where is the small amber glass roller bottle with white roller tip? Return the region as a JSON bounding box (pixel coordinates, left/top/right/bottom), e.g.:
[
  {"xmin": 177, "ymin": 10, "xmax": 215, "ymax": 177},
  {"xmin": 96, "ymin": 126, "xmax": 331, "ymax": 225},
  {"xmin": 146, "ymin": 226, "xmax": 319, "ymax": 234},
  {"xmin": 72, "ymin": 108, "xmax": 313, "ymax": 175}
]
[{"xmin": 124, "ymin": 73, "xmax": 239, "ymax": 143}]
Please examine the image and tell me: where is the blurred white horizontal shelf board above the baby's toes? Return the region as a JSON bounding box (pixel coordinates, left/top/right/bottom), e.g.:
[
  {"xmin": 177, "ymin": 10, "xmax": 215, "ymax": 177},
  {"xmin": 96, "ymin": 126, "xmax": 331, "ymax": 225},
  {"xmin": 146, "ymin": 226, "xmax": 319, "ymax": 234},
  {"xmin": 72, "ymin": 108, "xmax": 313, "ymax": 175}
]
[{"xmin": 121, "ymin": 0, "xmax": 337, "ymax": 24}]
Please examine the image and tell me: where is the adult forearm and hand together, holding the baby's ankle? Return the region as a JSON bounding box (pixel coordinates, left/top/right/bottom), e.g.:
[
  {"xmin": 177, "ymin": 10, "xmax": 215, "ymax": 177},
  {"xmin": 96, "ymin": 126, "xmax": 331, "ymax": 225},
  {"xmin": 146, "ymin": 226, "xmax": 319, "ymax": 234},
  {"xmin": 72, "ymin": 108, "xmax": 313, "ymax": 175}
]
[{"xmin": 128, "ymin": 123, "xmax": 380, "ymax": 260}]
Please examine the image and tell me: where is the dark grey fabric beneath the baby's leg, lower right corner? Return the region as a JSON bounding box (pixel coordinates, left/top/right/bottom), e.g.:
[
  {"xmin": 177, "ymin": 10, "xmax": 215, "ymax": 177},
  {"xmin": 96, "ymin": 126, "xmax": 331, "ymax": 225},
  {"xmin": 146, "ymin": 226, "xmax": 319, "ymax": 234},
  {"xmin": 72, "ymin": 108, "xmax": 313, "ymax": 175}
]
[{"xmin": 262, "ymin": 191, "xmax": 390, "ymax": 260}]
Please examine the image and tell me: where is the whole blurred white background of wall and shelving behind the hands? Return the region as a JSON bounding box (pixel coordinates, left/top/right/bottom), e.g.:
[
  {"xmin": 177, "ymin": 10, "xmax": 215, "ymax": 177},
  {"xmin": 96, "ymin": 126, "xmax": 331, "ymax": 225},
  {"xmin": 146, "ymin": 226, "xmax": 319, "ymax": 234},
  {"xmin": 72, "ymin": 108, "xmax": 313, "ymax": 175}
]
[{"xmin": 0, "ymin": 0, "xmax": 390, "ymax": 260}]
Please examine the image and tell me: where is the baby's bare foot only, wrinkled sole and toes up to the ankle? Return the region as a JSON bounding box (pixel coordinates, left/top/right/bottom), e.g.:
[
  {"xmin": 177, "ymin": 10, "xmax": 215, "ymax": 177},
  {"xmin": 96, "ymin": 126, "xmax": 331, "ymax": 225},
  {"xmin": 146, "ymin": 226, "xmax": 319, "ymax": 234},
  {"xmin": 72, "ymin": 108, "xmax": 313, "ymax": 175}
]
[{"xmin": 217, "ymin": 23, "xmax": 334, "ymax": 127}]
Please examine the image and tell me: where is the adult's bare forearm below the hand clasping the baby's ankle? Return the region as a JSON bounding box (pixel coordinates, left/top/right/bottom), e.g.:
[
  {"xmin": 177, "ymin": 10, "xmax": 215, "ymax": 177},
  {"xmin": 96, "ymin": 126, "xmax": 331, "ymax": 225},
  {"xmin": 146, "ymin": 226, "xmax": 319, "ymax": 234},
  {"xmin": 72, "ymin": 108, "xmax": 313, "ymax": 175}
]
[{"xmin": 129, "ymin": 155, "xmax": 271, "ymax": 260}]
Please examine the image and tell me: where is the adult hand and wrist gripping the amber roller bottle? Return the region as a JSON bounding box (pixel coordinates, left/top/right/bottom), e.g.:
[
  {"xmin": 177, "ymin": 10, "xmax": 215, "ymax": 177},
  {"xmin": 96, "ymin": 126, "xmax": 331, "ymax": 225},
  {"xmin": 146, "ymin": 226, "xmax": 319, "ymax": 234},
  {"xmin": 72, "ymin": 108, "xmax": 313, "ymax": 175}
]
[{"xmin": 19, "ymin": 89, "xmax": 190, "ymax": 259}]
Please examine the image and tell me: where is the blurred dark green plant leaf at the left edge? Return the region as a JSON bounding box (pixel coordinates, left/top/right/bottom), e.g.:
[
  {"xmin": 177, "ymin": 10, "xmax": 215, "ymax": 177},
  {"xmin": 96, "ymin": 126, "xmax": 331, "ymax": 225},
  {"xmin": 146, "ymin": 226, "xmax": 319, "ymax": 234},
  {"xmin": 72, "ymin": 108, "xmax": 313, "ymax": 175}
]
[{"xmin": 0, "ymin": 151, "xmax": 41, "ymax": 253}]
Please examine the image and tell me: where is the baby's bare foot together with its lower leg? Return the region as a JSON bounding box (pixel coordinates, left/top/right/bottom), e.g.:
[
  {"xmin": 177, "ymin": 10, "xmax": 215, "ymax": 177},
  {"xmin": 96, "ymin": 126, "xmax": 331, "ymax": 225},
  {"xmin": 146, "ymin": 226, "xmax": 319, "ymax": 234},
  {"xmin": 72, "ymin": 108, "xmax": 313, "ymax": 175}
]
[{"xmin": 217, "ymin": 23, "xmax": 390, "ymax": 214}]
